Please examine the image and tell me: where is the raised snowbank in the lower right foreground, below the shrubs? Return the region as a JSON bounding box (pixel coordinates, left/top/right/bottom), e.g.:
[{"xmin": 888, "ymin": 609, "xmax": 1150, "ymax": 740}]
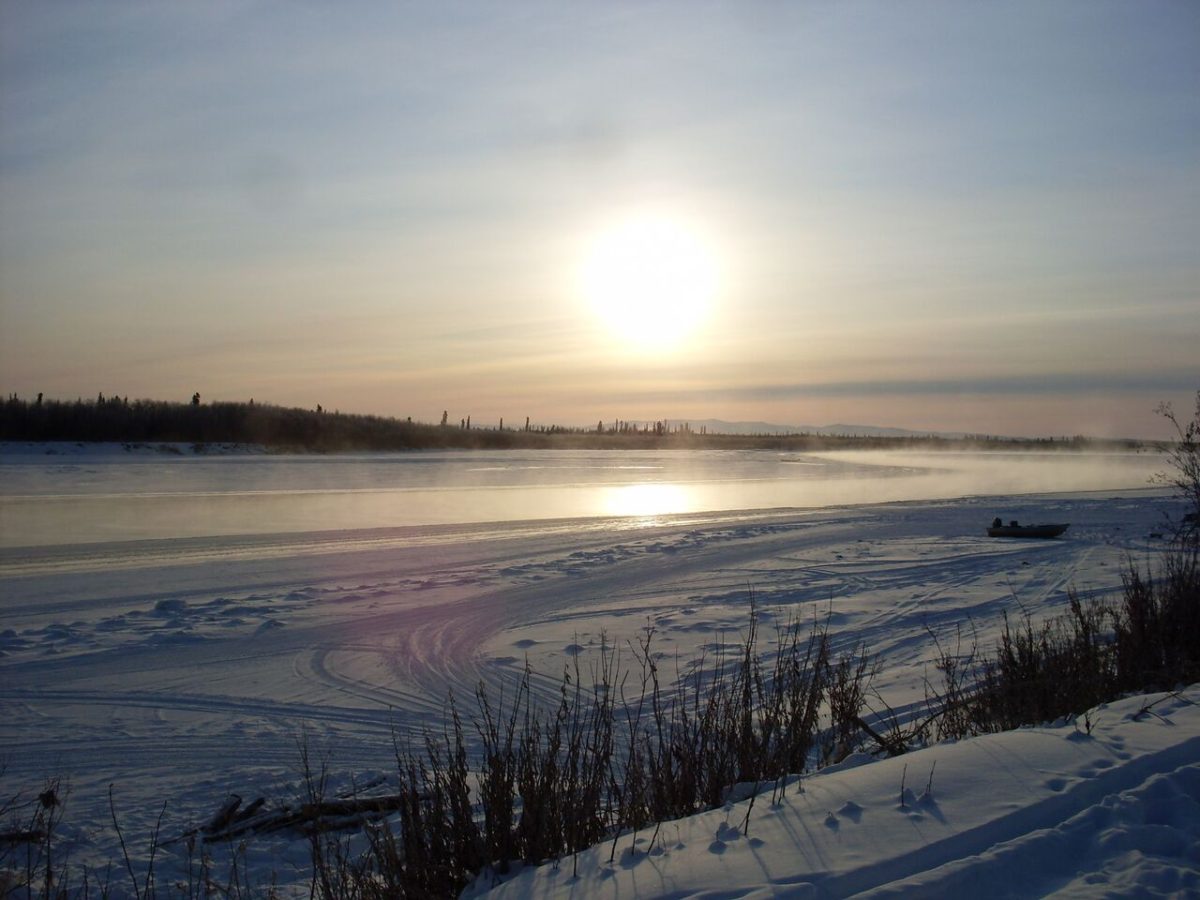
[{"xmin": 468, "ymin": 689, "xmax": 1200, "ymax": 900}]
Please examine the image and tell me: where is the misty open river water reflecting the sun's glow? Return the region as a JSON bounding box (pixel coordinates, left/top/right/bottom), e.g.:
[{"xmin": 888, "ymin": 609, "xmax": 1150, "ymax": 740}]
[{"xmin": 0, "ymin": 446, "xmax": 1165, "ymax": 562}]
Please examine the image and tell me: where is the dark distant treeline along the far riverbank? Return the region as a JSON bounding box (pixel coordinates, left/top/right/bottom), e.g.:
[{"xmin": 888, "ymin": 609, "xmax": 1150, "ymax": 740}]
[{"xmin": 0, "ymin": 394, "xmax": 1142, "ymax": 452}]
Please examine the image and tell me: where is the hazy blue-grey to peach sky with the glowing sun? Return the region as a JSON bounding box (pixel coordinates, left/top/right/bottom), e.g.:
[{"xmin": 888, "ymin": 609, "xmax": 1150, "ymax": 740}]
[{"xmin": 0, "ymin": 0, "xmax": 1200, "ymax": 437}]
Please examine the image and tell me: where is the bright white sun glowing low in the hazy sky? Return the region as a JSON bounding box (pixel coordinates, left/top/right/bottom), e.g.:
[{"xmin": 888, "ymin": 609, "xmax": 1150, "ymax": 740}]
[{"xmin": 580, "ymin": 214, "xmax": 718, "ymax": 348}]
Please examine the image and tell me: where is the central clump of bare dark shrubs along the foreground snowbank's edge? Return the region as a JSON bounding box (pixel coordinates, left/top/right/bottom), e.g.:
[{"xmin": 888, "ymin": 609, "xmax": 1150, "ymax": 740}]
[{"xmin": 313, "ymin": 604, "xmax": 875, "ymax": 896}]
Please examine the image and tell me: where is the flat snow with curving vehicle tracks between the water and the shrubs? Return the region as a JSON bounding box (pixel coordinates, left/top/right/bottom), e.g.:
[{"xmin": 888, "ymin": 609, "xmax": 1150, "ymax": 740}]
[{"xmin": 0, "ymin": 498, "xmax": 1176, "ymax": 775}]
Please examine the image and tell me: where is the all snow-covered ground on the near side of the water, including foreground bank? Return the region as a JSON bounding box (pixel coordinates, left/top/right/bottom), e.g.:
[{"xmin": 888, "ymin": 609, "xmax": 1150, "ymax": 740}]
[{"xmin": 0, "ymin": 480, "xmax": 1200, "ymax": 898}]
